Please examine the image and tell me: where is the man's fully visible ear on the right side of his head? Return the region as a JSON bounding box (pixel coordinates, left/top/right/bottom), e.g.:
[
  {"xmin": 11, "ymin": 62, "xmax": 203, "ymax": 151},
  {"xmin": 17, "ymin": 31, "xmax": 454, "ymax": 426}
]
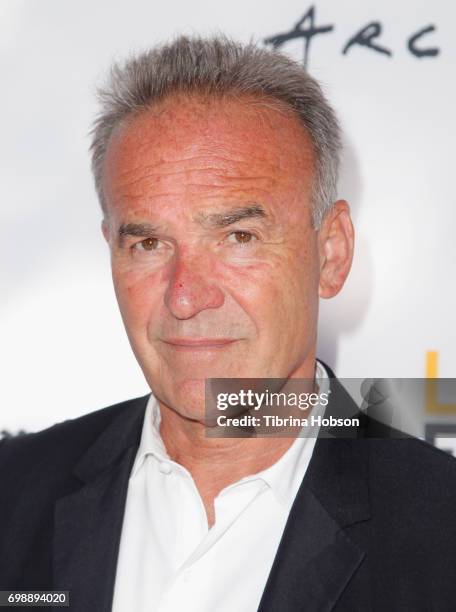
[{"xmin": 318, "ymin": 200, "xmax": 355, "ymax": 298}]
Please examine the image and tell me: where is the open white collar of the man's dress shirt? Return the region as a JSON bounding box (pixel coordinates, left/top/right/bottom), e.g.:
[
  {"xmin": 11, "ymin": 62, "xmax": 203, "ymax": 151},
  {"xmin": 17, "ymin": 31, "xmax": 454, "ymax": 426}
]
[{"xmin": 131, "ymin": 361, "xmax": 330, "ymax": 506}]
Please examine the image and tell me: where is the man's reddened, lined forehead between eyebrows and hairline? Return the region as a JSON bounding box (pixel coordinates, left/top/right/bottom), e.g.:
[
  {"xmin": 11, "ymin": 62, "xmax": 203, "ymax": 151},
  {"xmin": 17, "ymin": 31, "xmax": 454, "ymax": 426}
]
[{"xmin": 104, "ymin": 95, "xmax": 314, "ymax": 218}]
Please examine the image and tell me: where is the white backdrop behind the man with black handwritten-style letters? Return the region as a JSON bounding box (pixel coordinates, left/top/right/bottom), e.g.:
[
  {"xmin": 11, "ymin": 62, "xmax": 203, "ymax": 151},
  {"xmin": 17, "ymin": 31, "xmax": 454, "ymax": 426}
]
[{"xmin": 0, "ymin": 0, "xmax": 456, "ymax": 431}]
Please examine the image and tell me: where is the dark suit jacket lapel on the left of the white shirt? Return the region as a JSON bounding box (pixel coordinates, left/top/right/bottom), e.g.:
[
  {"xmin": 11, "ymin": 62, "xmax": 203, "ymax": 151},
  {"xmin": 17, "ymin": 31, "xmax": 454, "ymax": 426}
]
[{"xmin": 54, "ymin": 397, "xmax": 148, "ymax": 612}]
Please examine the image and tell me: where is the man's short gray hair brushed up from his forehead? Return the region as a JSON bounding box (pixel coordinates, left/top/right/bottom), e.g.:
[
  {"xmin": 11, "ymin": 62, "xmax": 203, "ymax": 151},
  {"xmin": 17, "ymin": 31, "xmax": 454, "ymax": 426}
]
[{"xmin": 91, "ymin": 36, "xmax": 341, "ymax": 228}]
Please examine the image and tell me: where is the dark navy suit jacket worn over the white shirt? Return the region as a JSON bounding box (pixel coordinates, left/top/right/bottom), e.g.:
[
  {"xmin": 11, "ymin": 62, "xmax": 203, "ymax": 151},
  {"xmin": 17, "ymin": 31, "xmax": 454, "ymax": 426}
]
[{"xmin": 0, "ymin": 370, "xmax": 456, "ymax": 612}]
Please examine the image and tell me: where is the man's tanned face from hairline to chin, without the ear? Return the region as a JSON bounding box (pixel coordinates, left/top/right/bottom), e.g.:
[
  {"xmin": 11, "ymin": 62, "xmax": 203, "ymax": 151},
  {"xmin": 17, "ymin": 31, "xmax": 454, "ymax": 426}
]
[{"xmin": 104, "ymin": 97, "xmax": 348, "ymax": 420}]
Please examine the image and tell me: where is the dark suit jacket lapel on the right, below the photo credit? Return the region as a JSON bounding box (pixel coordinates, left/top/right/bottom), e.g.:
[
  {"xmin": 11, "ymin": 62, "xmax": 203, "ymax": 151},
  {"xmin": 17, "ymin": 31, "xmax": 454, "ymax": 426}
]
[{"xmin": 259, "ymin": 380, "xmax": 370, "ymax": 612}]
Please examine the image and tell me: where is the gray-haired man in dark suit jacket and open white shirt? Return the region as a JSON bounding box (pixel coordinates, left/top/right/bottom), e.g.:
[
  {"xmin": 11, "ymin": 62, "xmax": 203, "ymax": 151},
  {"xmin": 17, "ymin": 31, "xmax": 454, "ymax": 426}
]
[{"xmin": 0, "ymin": 38, "xmax": 456, "ymax": 612}]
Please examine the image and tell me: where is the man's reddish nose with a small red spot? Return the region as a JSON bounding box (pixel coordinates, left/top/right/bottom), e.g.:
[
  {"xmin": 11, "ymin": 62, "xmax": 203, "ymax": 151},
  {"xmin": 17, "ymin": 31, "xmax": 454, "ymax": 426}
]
[{"xmin": 165, "ymin": 250, "xmax": 225, "ymax": 319}]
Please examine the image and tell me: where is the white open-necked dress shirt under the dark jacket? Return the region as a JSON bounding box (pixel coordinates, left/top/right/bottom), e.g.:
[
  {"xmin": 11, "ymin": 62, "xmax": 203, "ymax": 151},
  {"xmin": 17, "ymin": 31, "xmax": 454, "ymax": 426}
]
[{"xmin": 112, "ymin": 362, "xmax": 329, "ymax": 612}]
